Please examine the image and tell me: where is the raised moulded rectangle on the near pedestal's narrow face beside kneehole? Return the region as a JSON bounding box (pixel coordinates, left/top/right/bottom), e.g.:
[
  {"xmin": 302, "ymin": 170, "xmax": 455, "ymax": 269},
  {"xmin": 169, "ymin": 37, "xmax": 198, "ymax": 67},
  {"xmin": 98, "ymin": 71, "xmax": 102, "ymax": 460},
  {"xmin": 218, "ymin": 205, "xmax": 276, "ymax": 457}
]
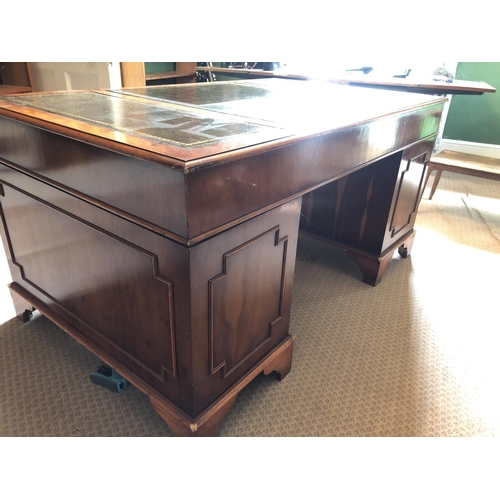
[{"xmin": 209, "ymin": 227, "xmax": 288, "ymax": 378}]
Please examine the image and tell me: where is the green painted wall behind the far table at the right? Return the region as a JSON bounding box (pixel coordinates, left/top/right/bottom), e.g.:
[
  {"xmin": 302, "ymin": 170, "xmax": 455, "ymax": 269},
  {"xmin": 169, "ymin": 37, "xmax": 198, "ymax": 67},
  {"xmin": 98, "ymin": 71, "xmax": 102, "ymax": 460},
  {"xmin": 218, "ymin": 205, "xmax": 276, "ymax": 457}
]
[{"xmin": 443, "ymin": 62, "xmax": 500, "ymax": 145}]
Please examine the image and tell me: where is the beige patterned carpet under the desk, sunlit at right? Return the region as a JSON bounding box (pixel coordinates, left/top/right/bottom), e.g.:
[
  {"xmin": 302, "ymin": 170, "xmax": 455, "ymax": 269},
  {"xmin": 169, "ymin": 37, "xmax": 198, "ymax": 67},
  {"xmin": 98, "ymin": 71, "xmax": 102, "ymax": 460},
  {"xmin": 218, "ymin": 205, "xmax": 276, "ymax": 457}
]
[{"xmin": 0, "ymin": 172, "xmax": 500, "ymax": 436}]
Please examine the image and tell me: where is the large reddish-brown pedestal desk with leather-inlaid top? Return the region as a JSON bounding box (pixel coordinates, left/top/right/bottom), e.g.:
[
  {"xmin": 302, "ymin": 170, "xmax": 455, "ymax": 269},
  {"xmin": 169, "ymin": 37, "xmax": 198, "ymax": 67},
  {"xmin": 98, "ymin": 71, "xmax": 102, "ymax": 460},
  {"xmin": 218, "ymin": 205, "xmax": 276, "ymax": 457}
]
[{"xmin": 0, "ymin": 80, "xmax": 445, "ymax": 436}]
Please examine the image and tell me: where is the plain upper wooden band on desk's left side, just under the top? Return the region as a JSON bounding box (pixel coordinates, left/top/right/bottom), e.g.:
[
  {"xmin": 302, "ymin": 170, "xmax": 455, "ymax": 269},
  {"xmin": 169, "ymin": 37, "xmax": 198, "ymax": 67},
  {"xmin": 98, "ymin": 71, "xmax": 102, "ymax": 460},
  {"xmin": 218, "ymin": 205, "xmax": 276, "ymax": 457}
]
[{"xmin": 0, "ymin": 117, "xmax": 187, "ymax": 237}]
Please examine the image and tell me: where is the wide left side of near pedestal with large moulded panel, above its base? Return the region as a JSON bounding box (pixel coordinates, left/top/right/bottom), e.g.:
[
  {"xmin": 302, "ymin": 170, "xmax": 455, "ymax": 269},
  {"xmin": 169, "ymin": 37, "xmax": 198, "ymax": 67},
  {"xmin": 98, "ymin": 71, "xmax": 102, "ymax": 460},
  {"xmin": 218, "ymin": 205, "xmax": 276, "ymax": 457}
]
[{"xmin": 0, "ymin": 167, "xmax": 192, "ymax": 406}]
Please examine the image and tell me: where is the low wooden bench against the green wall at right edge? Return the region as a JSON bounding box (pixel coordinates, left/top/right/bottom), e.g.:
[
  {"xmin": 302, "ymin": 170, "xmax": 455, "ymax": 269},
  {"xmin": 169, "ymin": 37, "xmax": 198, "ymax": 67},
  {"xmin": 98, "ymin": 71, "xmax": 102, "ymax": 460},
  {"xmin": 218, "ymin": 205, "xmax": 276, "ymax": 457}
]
[{"xmin": 426, "ymin": 150, "xmax": 500, "ymax": 200}]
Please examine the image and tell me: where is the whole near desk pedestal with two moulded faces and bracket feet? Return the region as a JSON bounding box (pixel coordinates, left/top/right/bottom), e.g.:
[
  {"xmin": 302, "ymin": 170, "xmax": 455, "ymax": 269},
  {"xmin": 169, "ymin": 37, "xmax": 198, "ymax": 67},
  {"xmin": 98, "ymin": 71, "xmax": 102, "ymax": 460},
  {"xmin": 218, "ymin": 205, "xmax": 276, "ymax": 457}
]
[{"xmin": 1, "ymin": 174, "xmax": 301, "ymax": 436}]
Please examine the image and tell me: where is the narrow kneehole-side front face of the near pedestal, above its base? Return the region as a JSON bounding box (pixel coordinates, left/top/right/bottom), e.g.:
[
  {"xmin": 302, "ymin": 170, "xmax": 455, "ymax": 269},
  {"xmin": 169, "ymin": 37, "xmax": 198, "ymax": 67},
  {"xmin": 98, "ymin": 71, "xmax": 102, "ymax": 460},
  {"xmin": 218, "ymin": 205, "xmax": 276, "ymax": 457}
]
[{"xmin": 191, "ymin": 198, "xmax": 301, "ymax": 415}]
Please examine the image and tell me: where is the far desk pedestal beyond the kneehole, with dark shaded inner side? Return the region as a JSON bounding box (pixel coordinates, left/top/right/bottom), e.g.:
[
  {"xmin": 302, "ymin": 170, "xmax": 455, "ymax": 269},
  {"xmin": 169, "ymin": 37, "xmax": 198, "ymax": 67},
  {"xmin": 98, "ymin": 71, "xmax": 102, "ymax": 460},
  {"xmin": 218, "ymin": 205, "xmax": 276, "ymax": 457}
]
[{"xmin": 301, "ymin": 138, "xmax": 434, "ymax": 286}]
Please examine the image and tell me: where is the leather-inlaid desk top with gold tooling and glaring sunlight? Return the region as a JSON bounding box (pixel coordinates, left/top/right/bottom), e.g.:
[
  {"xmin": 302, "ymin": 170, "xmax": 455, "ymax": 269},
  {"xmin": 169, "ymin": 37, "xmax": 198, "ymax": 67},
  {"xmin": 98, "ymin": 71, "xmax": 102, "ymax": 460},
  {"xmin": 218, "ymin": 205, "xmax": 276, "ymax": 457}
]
[{"xmin": 0, "ymin": 79, "xmax": 445, "ymax": 171}]
